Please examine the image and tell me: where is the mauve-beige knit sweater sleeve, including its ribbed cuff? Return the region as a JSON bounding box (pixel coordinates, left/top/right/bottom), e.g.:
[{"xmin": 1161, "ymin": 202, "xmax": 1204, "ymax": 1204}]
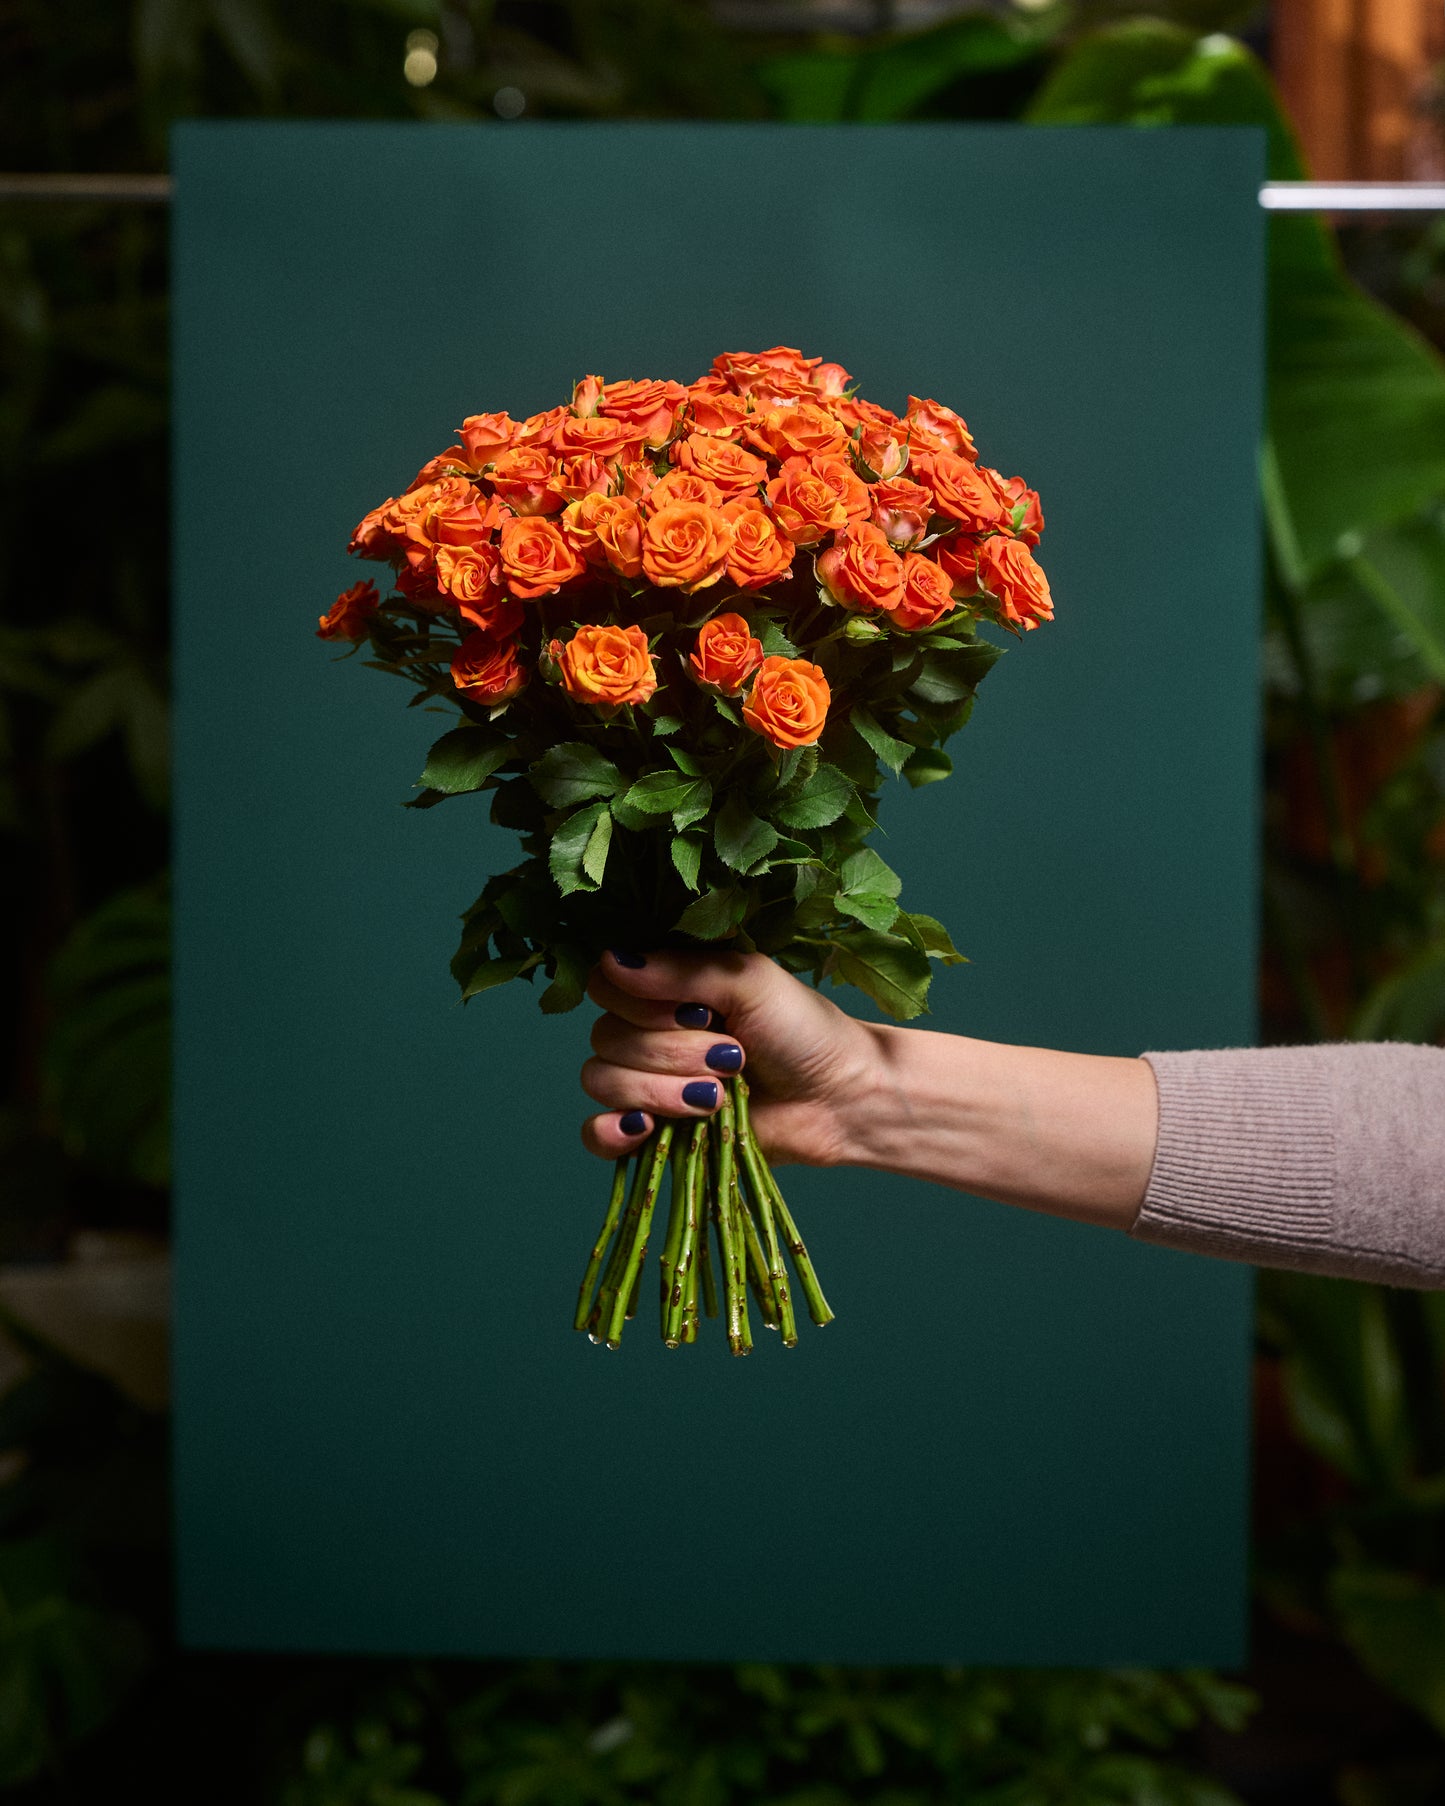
[{"xmin": 1133, "ymin": 1042, "xmax": 1445, "ymax": 1288}]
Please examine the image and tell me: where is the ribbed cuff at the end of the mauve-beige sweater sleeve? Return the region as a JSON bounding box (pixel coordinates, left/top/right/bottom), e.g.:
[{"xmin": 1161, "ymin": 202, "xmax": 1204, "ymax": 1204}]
[{"xmin": 1133, "ymin": 1047, "xmax": 1337, "ymax": 1266}]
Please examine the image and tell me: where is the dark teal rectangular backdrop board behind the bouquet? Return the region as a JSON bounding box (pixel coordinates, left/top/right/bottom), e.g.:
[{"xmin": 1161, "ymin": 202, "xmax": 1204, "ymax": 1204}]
[{"xmin": 175, "ymin": 125, "xmax": 1263, "ymax": 1663}]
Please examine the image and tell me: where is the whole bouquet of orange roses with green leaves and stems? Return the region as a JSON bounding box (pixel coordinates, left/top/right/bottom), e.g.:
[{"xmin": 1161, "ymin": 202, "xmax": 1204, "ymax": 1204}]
[{"xmin": 320, "ymin": 347, "xmax": 1053, "ymax": 1355}]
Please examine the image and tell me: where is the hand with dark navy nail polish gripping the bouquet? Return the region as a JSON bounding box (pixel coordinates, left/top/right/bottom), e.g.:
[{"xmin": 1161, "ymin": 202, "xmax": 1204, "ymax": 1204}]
[{"xmin": 582, "ymin": 954, "xmax": 880, "ymax": 1167}]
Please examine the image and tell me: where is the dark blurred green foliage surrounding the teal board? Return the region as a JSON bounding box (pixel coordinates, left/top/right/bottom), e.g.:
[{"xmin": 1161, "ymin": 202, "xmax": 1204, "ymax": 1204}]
[{"xmin": 0, "ymin": 0, "xmax": 1445, "ymax": 1806}]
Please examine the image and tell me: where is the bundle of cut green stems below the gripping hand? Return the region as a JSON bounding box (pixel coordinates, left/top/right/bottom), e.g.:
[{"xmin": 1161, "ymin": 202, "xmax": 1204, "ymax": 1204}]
[{"xmin": 573, "ymin": 1075, "xmax": 833, "ymax": 1355}]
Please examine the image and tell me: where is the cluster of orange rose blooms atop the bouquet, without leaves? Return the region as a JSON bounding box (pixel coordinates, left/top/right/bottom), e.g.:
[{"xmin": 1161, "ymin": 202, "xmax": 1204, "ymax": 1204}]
[{"xmin": 320, "ymin": 347, "xmax": 1053, "ymax": 749}]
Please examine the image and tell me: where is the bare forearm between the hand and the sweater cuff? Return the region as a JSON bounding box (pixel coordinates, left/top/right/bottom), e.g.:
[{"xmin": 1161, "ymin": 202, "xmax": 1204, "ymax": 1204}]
[{"xmin": 847, "ymin": 1024, "xmax": 1158, "ymax": 1230}]
